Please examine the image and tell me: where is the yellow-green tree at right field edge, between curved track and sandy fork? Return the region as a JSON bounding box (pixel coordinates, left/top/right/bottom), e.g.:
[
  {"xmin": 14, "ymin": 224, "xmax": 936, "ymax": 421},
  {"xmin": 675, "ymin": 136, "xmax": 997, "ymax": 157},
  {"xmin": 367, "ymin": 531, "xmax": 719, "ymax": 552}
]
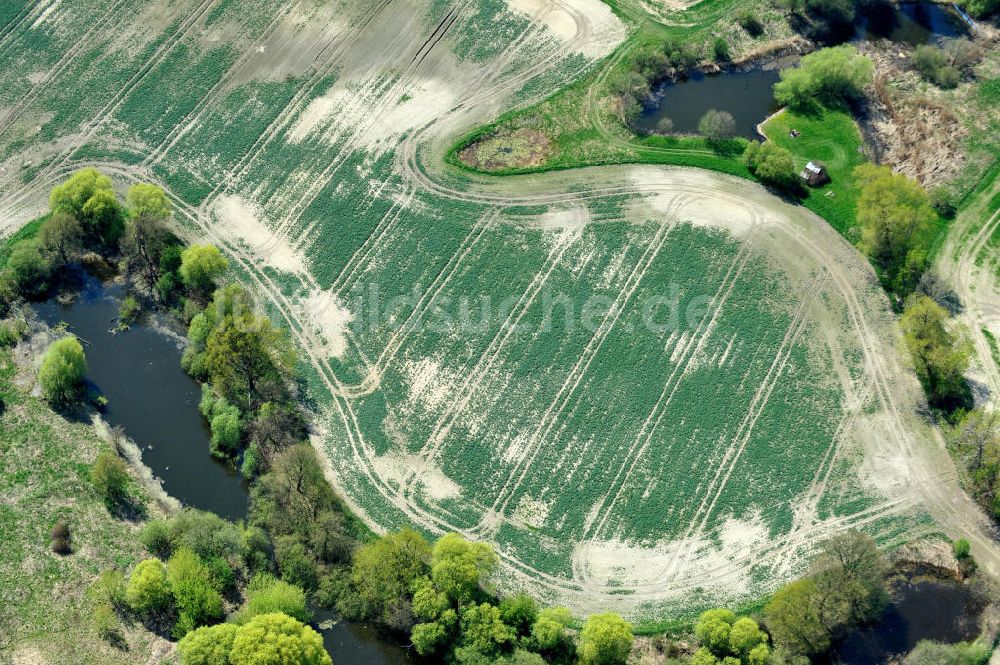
[{"xmin": 900, "ymin": 296, "xmax": 972, "ymax": 408}]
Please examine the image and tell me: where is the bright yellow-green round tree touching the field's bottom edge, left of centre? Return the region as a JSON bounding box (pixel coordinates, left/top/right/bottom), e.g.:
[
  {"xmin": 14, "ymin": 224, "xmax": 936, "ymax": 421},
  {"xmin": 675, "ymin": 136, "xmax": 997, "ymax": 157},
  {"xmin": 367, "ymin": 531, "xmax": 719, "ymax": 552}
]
[{"xmin": 431, "ymin": 533, "xmax": 499, "ymax": 603}]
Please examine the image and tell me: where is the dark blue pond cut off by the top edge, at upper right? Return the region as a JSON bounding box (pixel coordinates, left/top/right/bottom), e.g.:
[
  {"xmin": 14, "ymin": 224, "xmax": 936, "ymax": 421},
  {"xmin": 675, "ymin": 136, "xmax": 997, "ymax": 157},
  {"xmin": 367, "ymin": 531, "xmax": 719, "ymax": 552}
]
[{"xmin": 854, "ymin": 2, "xmax": 968, "ymax": 46}]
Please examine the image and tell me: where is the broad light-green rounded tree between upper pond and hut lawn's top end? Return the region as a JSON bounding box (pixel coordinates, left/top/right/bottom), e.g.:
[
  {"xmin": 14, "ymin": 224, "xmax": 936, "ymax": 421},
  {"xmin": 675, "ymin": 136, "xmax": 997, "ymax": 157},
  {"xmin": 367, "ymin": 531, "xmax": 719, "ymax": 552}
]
[{"xmin": 774, "ymin": 44, "xmax": 875, "ymax": 110}]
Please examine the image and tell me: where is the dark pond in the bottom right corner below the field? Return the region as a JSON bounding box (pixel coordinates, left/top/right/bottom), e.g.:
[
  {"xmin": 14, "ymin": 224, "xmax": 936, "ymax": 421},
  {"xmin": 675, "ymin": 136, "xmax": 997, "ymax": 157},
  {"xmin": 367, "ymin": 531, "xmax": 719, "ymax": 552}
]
[{"xmin": 836, "ymin": 578, "xmax": 983, "ymax": 665}]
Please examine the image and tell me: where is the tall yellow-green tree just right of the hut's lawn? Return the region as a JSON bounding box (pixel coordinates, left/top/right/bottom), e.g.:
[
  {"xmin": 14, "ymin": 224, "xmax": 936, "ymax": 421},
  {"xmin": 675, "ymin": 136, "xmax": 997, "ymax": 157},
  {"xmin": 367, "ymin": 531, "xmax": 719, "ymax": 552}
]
[{"xmin": 854, "ymin": 164, "xmax": 935, "ymax": 286}]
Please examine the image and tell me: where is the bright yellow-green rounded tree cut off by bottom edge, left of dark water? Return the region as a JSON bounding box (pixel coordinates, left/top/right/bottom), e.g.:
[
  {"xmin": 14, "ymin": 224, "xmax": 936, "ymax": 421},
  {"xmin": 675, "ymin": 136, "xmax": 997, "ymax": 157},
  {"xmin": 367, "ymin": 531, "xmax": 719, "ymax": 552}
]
[{"xmin": 229, "ymin": 612, "xmax": 333, "ymax": 665}]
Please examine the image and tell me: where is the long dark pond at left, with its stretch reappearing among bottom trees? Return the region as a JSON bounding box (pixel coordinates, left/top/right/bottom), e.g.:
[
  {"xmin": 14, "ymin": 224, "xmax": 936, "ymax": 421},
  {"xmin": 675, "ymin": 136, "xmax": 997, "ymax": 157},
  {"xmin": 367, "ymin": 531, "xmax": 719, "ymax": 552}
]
[{"xmin": 35, "ymin": 275, "xmax": 415, "ymax": 665}]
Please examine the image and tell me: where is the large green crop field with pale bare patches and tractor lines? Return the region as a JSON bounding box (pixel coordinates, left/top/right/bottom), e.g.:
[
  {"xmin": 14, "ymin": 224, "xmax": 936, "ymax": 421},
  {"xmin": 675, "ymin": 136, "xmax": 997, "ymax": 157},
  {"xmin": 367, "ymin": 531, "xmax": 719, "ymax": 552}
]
[{"xmin": 0, "ymin": 0, "xmax": 952, "ymax": 627}]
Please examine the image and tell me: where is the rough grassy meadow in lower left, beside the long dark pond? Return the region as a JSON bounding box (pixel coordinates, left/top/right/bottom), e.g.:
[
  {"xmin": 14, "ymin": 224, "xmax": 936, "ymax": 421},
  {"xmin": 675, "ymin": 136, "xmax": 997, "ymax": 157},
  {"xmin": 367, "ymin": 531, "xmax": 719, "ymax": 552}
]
[{"xmin": 0, "ymin": 349, "xmax": 154, "ymax": 665}]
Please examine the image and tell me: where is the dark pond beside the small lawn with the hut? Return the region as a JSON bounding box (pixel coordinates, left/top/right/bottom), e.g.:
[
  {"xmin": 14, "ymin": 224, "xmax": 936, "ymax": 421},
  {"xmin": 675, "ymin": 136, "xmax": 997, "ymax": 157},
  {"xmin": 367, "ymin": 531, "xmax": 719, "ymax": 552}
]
[{"xmin": 635, "ymin": 67, "xmax": 778, "ymax": 138}]
